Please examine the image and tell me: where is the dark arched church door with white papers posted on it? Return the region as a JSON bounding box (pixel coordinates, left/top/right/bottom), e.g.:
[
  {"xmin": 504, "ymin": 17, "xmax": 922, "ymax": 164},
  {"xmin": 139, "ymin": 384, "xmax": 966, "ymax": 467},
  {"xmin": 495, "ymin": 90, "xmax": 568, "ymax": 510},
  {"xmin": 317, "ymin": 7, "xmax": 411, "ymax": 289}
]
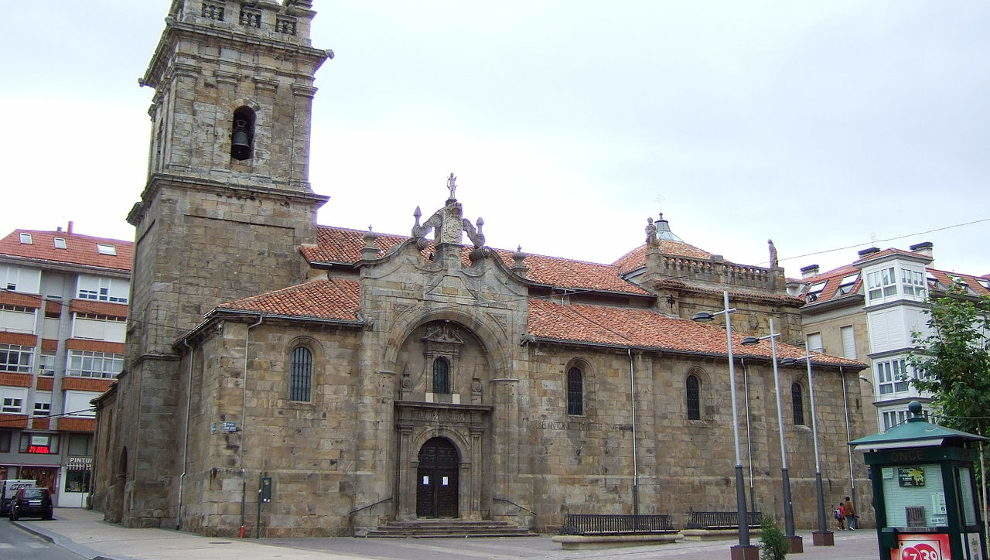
[{"xmin": 416, "ymin": 437, "xmax": 460, "ymax": 517}]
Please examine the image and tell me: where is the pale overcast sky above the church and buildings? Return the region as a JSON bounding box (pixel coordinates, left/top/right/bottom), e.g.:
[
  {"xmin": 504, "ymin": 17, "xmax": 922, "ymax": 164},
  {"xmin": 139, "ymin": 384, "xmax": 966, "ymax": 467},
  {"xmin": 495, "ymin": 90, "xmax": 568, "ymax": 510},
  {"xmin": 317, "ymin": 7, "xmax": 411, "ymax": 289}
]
[{"xmin": 0, "ymin": 0, "xmax": 990, "ymax": 276}]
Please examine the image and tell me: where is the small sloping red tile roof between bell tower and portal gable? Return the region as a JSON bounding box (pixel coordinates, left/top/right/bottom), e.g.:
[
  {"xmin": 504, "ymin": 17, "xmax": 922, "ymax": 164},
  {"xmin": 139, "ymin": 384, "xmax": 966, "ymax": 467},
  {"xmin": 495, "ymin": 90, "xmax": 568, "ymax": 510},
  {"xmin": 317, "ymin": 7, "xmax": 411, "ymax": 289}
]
[{"xmin": 217, "ymin": 278, "xmax": 361, "ymax": 321}]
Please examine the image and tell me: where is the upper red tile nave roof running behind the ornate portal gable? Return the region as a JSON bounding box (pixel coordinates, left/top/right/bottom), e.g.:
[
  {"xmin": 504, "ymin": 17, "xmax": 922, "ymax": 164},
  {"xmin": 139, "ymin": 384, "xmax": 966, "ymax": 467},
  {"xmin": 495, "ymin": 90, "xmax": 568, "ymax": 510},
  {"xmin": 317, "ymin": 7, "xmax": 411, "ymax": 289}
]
[{"xmin": 300, "ymin": 226, "xmax": 649, "ymax": 295}]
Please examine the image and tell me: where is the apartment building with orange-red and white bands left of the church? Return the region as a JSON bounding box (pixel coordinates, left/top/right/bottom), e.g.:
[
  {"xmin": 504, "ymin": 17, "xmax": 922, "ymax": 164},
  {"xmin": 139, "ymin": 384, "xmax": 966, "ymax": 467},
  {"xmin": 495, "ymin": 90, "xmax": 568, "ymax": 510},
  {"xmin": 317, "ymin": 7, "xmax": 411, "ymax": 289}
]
[{"xmin": 0, "ymin": 222, "xmax": 133, "ymax": 507}]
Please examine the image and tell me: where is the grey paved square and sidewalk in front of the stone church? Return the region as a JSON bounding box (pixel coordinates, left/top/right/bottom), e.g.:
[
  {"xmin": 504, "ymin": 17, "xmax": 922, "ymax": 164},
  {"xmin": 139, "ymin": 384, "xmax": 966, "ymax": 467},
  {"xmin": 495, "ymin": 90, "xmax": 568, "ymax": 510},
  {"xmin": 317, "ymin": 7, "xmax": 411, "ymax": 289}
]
[{"xmin": 14, "ymin": 509, "xmax": 877, "ymax": 560}]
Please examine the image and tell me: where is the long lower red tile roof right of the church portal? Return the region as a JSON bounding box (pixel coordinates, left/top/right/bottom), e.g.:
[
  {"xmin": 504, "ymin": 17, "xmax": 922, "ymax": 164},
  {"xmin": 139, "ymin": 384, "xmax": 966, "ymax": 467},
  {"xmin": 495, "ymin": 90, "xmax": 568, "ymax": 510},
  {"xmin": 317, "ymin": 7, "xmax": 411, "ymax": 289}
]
[{"xmin": 526, "ymin": 299, "xmax": 863, "ymax": 368}]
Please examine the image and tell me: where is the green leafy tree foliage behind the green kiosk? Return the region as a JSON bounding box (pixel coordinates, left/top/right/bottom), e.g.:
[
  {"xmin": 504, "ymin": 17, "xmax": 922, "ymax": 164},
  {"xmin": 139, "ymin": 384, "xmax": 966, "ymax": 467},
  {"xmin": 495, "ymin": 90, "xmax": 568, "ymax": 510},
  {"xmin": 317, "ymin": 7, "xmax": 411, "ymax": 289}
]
[{"xmin": 909, "ymin": 289, "xmax": 990, "ymax": 434}]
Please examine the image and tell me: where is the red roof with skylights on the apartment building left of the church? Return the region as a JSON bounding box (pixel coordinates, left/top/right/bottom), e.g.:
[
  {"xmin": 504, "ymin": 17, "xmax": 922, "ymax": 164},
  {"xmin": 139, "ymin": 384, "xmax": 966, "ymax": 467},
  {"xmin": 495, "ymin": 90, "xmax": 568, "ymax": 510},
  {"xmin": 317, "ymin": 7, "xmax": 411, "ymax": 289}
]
[{"xmin": 0, "ymin": 229, "xmax": 134, "ymax": 272}]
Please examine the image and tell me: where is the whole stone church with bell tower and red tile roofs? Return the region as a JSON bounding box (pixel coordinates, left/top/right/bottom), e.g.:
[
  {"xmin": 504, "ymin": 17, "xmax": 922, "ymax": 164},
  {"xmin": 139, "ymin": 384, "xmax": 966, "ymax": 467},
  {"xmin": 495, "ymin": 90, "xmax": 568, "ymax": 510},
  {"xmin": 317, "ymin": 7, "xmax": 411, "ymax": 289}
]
[{"xmin": 93, "ymin": 0, "xmax": 868, "ymax": 536}]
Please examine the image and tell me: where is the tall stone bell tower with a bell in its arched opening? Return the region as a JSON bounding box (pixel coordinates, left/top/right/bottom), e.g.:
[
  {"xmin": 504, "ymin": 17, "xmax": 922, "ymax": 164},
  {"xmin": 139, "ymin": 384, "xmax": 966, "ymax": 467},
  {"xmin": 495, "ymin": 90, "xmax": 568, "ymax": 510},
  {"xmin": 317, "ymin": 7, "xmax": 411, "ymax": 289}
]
[{"xmin": 108, "ymin": 0, "xmax": 333, "ymax": 526}]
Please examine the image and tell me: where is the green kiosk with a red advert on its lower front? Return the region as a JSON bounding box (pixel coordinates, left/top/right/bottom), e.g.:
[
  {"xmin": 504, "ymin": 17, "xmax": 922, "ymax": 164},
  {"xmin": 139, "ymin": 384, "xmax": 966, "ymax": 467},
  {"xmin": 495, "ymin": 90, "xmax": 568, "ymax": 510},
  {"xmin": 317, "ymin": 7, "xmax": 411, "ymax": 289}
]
[{"xmin": 849, "ymin": 401, "xmax": 987, "ymax": 560}]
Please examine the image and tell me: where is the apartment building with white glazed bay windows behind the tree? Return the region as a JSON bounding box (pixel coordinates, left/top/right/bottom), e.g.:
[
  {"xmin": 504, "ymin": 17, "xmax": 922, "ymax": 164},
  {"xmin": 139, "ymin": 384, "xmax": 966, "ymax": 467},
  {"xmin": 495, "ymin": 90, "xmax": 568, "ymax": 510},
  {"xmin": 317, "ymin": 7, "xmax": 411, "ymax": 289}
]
[{"xmin": 800, "ymin": 242, "xmax": 990, "ymax": 431}]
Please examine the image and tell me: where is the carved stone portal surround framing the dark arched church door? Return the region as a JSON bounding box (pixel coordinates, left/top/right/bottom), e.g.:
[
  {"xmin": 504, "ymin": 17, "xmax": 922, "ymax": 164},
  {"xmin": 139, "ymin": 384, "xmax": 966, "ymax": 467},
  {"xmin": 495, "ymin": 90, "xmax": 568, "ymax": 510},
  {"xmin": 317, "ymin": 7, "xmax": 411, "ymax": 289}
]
[{"xmin": 395, "ymin": 401, "xmax": 491, "ymax": 520}]
